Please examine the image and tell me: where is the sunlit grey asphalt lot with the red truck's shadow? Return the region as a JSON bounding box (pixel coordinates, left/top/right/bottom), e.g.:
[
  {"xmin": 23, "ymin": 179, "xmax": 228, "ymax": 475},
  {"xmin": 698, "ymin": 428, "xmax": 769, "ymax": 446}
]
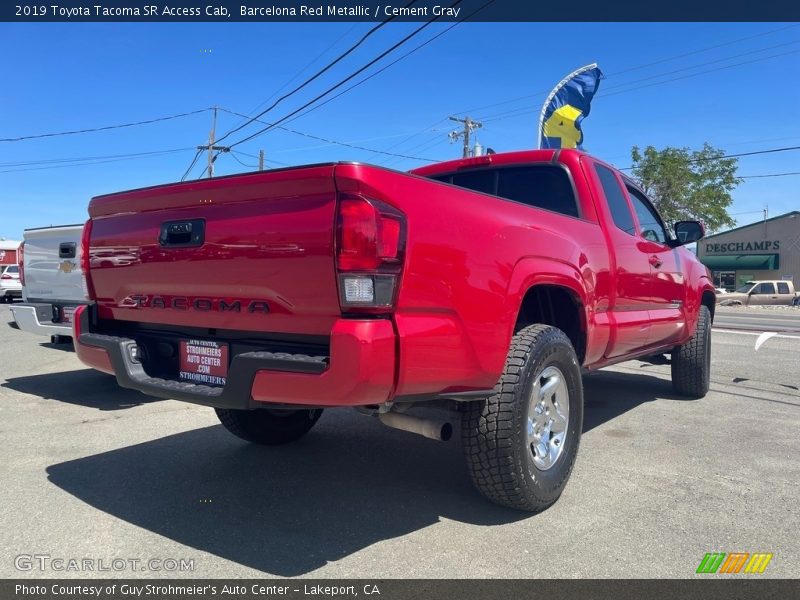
[{"xmin": 0, "ymin": 306, "xmax": 800, "ymax": 578}]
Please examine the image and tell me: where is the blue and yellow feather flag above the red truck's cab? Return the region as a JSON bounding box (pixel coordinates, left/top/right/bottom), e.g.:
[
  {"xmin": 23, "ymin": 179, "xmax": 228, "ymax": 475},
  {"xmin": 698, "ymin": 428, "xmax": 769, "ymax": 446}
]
[{"xmin": 539, "ymin": 64, "xmax": 603, "ymax": 148}]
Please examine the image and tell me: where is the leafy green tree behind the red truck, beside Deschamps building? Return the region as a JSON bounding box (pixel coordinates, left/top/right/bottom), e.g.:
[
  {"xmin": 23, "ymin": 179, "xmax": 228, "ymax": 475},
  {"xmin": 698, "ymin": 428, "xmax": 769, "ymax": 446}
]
[{"xmin": 631, "ymin": 143, "xmax": 742, "ymax": 233}]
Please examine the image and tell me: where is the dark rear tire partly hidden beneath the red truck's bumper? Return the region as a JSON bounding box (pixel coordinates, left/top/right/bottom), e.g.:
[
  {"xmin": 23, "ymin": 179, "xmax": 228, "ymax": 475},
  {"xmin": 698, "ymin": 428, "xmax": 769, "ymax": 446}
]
[{"xmin": 214, "ymin": 408, "xmax": 322, "ymax": 446}]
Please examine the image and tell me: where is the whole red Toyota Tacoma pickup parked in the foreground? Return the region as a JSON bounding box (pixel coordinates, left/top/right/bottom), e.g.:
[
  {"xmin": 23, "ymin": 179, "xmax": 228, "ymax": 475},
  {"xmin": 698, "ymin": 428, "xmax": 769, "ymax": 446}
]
[{"xmin": 74, "ymin": 150, "xmax": 715, "ymax": 511}]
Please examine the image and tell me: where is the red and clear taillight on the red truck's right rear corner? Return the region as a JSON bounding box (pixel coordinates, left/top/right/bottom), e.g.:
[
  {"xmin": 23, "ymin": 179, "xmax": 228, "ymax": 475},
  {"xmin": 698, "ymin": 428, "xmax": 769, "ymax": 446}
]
[{"xmin": 336, "ymin": 195, "xmax": 406, "ymax": 310}]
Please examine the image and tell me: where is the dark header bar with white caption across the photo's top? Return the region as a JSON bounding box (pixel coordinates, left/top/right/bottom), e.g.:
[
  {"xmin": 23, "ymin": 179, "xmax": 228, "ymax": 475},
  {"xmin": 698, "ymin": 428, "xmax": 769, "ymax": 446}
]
[{"xmin": 0, "ymin": 0, "xmax": 800, "ymax": 23}]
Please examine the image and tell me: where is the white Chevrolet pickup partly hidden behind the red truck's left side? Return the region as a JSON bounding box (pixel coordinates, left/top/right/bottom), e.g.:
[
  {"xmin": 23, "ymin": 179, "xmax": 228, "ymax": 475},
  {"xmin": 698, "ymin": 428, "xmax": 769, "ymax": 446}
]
[{"xmin": 11, "ymin": 225, "xmax": 87, "ymax": 343}]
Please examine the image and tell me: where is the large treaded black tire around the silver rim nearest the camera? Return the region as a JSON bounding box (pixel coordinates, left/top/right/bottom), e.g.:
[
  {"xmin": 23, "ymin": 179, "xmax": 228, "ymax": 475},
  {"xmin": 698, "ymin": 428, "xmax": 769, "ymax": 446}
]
[{"xmin": 462, "ymin": 325, "xmax": 583, "ymax": 512}]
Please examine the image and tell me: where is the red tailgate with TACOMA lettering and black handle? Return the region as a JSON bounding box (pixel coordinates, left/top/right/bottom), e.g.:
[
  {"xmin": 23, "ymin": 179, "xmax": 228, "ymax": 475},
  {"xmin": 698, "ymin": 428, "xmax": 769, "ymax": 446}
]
[{"xmin": 89, "ymin": 165, "xmax": 340, "ymax": 335}]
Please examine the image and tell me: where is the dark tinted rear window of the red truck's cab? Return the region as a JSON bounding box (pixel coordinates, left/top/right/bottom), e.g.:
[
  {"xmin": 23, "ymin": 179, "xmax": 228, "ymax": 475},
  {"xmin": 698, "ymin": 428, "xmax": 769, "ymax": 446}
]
[{"xmin": 432, "ymin": 165, "xmax": 580, "ymax": 217}]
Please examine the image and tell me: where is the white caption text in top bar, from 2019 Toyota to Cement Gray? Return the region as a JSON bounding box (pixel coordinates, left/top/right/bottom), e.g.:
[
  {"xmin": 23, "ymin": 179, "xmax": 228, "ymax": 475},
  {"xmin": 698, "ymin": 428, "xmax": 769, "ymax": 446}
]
[{"xmin": 14, "ymin": 4, "xmax": 461, "ymax": 19}]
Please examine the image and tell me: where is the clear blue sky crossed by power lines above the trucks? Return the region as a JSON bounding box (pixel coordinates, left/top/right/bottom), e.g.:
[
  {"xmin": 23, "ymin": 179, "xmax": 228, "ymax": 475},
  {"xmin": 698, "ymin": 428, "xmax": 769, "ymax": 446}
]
[{"xmin": 0, "ymin": 23, "xmax": 800, "ymax": 239}]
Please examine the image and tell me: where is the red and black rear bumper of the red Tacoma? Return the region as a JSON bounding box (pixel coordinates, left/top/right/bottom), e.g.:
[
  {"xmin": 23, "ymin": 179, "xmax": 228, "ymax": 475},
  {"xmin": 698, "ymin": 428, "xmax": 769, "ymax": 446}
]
[{"xmin": 74, "ymin": 306, "xmax": 396, "ymax": 409}]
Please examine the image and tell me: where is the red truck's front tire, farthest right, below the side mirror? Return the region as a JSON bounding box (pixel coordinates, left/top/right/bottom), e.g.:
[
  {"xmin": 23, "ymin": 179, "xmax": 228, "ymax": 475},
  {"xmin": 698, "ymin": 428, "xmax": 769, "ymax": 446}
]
[{"xmin": 671, "ymin": 306, "xmax": 711, "ymax": 398}]
